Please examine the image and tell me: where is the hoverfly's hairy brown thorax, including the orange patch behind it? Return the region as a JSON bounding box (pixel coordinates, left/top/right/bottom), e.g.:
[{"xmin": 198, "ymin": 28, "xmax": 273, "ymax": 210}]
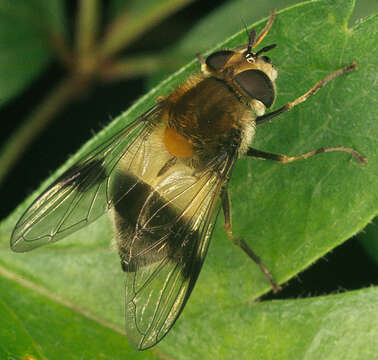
[{"xmin": 163, "ymin": 76, "xmax": 256, "ymax": 160}]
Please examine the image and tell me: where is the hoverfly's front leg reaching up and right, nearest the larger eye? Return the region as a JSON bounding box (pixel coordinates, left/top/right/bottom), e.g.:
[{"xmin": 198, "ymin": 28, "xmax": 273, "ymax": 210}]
[{"xmin": 256, "ymin": 61, "xmax": 358, "ymax": 125}]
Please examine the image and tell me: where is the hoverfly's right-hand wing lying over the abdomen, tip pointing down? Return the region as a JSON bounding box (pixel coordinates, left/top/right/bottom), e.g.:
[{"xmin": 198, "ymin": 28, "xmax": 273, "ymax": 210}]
[{"xmin": 115, "ymin": 155, "xmax": 236, "ymax": 349}]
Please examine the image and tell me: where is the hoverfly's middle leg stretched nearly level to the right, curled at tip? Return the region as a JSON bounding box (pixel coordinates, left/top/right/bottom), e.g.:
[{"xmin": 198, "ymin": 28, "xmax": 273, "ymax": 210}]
[{"xmin": 247, "ymin": 146, "xmax": 367, "ymax": 165}]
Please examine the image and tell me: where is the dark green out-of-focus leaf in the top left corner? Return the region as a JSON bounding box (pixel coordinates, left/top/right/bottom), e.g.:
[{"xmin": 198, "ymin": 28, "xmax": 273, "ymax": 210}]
[{"xmin": 0, "ymin": 0, "xmax": 64, "ymax": 107}]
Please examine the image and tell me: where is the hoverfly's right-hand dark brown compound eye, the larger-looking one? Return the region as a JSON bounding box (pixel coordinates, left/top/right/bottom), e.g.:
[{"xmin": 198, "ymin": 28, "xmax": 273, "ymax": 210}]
[{"xmin": 234, "ymin": 70, "xmax": 274, "ymax": 108}]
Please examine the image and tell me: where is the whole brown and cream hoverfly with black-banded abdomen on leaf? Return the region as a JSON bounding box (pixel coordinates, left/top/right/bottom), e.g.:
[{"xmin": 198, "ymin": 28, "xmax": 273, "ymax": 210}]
[{"xmin": 11, "ymin": 12, "xmax": 365, "ymax": 350}]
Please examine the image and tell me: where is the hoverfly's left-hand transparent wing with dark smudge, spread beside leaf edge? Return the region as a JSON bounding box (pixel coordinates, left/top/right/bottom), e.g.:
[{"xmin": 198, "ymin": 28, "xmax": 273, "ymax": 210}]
[{"xmin": 11, "ymin": 105, "xmax": 159, "ymax": 252}]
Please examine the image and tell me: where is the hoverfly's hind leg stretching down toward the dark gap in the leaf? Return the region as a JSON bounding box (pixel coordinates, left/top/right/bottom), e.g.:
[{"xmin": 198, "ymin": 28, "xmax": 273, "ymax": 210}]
[{"xmin": 221, "ymin": 189, "xmax": 281, "ymax": 292}]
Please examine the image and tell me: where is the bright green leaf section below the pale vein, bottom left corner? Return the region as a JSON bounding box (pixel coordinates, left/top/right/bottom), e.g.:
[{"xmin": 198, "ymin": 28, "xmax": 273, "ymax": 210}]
[{"xmin": 0, "ymin": 268, "xmax": 156, "ymax": 360}]
